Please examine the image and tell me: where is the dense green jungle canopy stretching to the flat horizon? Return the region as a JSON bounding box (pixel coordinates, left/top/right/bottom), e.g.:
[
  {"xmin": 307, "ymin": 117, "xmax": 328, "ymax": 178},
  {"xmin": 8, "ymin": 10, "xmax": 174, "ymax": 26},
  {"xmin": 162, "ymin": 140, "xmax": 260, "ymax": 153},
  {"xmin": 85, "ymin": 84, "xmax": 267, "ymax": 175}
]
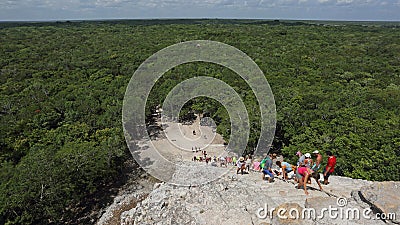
[{"xmin": 0, "ymin": 20, "xmax": 400, "ymax": 224}]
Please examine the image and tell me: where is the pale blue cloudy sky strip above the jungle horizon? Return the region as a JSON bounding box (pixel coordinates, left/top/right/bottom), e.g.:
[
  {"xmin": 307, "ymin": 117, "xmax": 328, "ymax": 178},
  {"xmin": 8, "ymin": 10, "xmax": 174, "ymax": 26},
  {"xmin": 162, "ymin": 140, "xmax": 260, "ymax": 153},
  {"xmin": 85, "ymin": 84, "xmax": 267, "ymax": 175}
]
[{"xmin": 0, "ymin": 0, "xmax": 400, "ymax": 21}]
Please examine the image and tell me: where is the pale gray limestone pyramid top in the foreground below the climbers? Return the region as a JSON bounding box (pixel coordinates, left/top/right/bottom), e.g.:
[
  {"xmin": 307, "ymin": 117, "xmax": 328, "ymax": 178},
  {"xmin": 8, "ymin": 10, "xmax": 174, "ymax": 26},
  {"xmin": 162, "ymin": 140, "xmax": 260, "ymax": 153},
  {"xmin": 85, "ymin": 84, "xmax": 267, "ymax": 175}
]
[{"xmin": 99, "ymin": 162, "xmax": 400, "ymax": 225}]
